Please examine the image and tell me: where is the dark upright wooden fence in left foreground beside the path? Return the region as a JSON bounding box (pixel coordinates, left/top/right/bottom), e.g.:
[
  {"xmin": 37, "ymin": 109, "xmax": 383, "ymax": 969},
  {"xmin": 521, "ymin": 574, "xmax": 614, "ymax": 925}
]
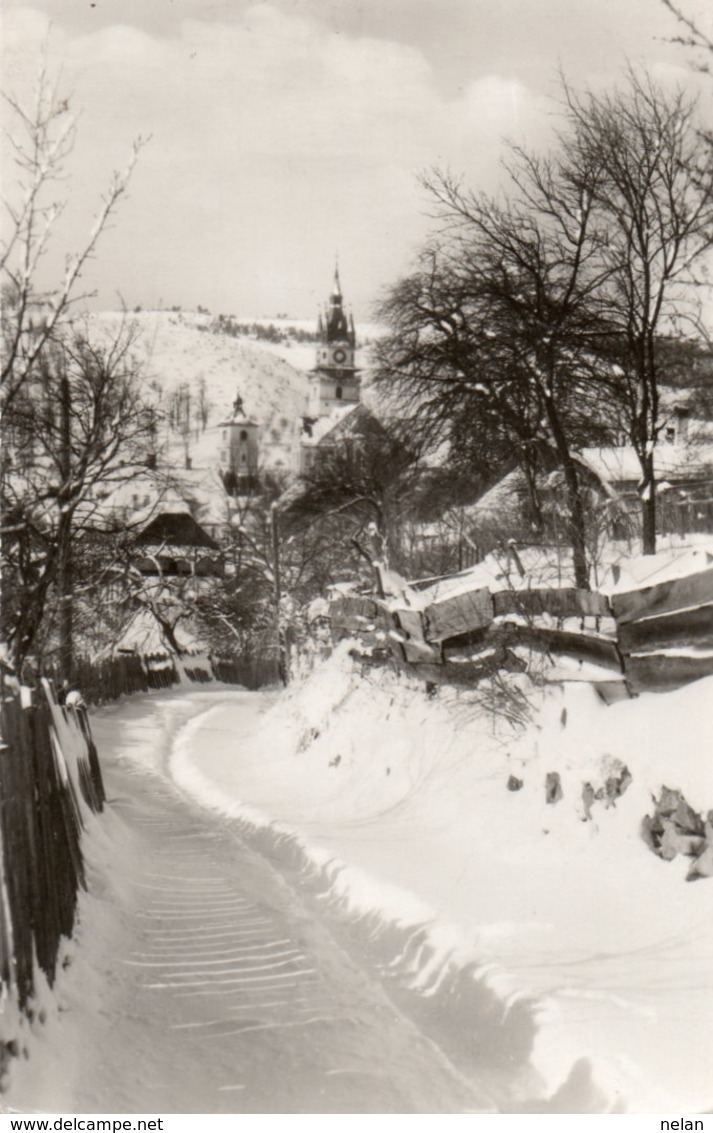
[{"xmin": 0, "ymin": 674, "xmax": 104, "ymax": 1010}]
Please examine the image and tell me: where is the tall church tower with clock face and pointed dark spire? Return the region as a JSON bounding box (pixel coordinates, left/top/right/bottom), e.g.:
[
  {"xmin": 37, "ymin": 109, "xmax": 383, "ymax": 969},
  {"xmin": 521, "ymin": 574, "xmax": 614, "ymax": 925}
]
[{"xmin": 307, "ymin": 267, "xmax": 360, "ymax": 417}]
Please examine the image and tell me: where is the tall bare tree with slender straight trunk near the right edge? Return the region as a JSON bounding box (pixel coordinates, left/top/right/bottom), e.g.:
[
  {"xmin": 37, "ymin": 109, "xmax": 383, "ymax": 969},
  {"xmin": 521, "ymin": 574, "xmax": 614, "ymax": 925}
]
[{"xmin": 565, "ymin": 70, "xmax": 713, "ymax": 554}]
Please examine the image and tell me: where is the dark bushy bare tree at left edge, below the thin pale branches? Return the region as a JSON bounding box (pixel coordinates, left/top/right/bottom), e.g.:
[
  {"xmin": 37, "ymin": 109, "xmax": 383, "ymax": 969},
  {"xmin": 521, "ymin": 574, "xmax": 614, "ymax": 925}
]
[{"xmin": 2, "ymin": 326, "xmax": 155, "ymax": 676}]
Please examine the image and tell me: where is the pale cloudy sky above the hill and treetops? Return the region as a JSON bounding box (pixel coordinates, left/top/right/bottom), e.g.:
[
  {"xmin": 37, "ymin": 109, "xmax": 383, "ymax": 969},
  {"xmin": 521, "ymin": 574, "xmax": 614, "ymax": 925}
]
[{"xmin": 3, "ymin": 0, "xmax": 711, "ymax": 320}]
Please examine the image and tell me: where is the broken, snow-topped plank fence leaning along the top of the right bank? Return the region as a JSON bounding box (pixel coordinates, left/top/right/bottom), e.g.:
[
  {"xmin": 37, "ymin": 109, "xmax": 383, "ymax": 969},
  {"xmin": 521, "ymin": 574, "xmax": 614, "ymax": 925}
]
[{"xmin": 330, "ymin": 568, "xmax": 713, "ymax": 693}]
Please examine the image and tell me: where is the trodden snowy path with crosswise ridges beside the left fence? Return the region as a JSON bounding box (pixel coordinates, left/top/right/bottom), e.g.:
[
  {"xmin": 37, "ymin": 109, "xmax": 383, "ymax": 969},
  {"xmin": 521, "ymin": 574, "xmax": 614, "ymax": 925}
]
[{"xmin": 11, "ymin": 688, "xmax": 490, "ymax": 1113}]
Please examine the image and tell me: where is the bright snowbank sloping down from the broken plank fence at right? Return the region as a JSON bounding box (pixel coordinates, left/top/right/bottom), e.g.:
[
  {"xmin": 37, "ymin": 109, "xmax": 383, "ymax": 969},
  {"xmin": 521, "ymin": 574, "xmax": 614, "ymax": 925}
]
[{"xmin": 172, "ymin": 647, "xmax": 713, "ymax": 1111}]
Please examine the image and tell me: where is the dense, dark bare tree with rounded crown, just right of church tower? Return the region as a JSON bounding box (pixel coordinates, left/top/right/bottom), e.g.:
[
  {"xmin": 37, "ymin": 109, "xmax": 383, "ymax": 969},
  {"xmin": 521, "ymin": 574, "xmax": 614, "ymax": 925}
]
[{"xmin": 373, "ymin": 251, "xmax": 553, "ymax": 539}]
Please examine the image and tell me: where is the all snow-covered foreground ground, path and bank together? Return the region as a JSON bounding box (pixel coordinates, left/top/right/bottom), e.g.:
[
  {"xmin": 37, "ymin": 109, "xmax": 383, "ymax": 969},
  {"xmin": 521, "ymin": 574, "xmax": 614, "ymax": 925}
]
[{"xmin": 10, "ymin": 653, "xmax": 713, "ymax": 1113}]
